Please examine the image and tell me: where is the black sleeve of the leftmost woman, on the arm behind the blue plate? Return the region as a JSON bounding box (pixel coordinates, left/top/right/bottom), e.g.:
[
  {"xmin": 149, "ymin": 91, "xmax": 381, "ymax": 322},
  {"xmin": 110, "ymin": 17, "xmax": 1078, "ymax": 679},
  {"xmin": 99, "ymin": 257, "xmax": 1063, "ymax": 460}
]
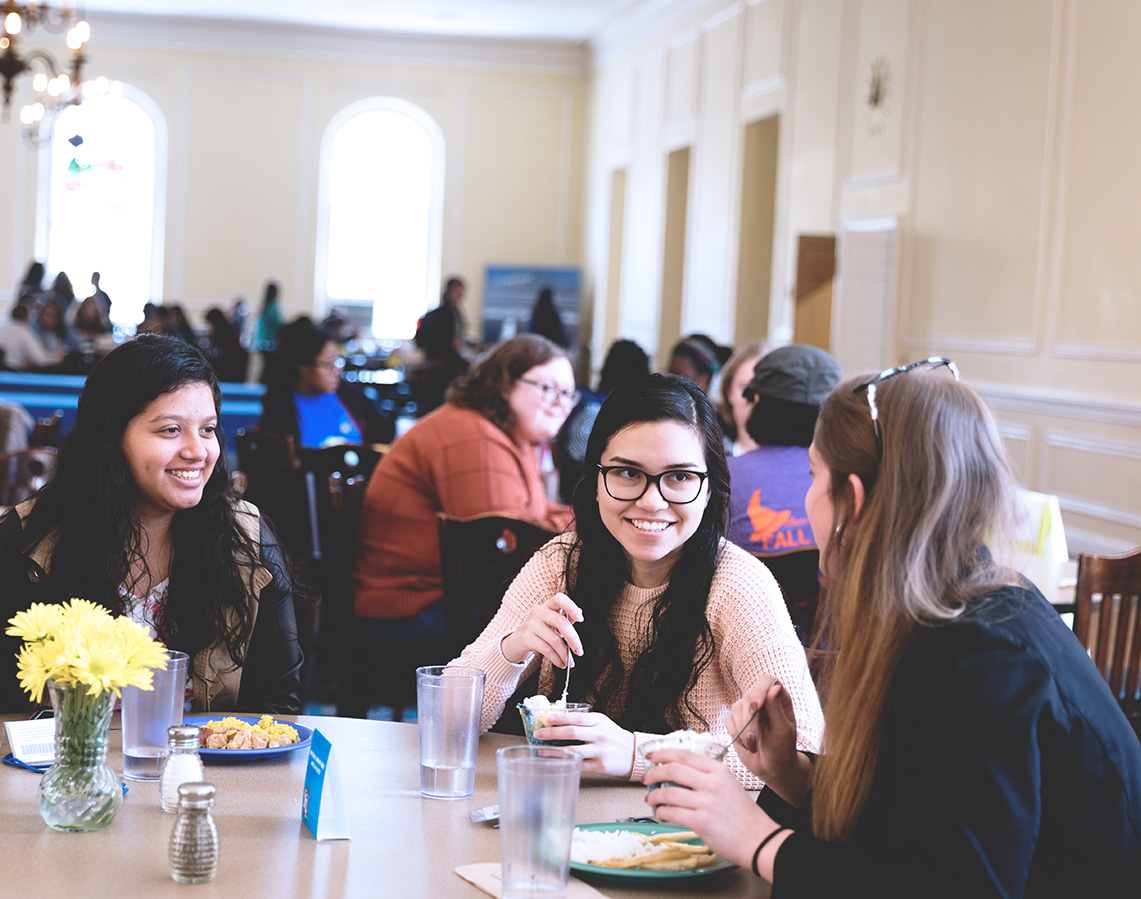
[{"xmin": 237, "ymin": 521, "xmax": 301, "ymax": 714}]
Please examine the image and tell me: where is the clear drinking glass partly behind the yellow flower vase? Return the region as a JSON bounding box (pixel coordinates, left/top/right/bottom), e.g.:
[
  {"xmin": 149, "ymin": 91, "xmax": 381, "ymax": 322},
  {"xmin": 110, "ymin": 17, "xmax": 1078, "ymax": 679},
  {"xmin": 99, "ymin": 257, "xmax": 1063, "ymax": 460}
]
[{"xmin": 122, "ymin": 651, "xmax": 191, "ymax": 780}]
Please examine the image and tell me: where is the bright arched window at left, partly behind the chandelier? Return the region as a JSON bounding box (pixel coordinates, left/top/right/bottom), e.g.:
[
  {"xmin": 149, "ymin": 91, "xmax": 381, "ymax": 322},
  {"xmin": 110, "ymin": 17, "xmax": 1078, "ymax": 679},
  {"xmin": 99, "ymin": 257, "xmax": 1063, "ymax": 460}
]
[{"xmin": 37, "ymin": 88, "xmax": 167, "ymax": 329}]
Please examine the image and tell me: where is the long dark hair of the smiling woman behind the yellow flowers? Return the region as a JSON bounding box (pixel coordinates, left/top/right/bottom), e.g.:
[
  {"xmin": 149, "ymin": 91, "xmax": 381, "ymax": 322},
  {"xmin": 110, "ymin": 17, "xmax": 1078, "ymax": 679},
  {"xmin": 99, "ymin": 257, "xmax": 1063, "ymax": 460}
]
[{"xmin": 25, "ymin": 334, "xmax": 260, "ymax": 665}]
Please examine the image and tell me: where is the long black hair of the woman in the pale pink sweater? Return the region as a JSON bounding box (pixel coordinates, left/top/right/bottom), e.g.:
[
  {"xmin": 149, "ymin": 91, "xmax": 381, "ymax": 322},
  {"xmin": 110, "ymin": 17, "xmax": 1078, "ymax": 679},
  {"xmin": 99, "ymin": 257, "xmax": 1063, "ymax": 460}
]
[{"xmin": 566, "ymin": 374, "xmax": 729, "ymax": 734}]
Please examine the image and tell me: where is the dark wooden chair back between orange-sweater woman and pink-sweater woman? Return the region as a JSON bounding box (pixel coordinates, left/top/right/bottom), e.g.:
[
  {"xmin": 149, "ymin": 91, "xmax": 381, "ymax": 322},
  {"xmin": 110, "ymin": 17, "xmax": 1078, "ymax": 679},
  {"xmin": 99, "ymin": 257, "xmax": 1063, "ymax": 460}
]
[{"xmin": 437, "ymin": 512, "xmax": 555, "ymax": 658}]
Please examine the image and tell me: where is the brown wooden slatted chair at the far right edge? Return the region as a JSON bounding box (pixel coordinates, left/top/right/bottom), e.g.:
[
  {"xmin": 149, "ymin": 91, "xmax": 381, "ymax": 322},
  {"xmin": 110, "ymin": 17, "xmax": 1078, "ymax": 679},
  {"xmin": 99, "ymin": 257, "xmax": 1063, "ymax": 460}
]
[{"xmin": 1074, "ymin": 548, "xmax": 1141, "ymax": 736}]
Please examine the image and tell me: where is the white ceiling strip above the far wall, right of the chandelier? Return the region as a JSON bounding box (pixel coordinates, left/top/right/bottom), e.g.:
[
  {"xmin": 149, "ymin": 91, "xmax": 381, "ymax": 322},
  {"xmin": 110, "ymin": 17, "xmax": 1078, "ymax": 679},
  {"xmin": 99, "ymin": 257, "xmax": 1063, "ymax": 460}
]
[{"xmin": 75, "ymin": 0, "xmax": 642, "ymax": 43}]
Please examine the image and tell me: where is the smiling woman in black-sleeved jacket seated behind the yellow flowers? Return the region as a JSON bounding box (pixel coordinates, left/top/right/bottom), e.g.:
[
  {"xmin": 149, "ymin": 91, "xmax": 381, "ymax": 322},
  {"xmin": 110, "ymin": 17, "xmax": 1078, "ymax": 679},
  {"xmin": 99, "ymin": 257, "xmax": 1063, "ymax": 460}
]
[{"xmin": 0, "ymin": 334, "xmax": 301, "ymax": 713}]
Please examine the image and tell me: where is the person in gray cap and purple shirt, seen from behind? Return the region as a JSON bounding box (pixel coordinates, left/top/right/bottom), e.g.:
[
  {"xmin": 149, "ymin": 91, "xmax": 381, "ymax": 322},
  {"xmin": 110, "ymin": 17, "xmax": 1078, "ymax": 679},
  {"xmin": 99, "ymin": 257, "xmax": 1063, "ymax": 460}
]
[{"xmin": 729, "ymin": 343, "xmax": 840, "ymax": 640}]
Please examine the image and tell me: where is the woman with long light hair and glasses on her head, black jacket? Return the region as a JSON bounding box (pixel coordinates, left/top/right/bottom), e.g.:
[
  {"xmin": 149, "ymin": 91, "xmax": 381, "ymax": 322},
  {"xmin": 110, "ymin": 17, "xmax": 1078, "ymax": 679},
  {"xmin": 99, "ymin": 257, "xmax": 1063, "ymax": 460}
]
[{"xmin": 646, "ymin": 358, "xmax": 1141, "ymax": 897}]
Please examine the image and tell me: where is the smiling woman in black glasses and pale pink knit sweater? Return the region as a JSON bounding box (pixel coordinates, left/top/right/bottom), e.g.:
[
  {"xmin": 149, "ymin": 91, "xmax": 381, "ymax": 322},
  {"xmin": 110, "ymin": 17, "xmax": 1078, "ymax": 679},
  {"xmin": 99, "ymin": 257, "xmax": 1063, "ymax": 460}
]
[{"xmin": 461, "ymin": 374, "xmax": 823, "ymax": 788}]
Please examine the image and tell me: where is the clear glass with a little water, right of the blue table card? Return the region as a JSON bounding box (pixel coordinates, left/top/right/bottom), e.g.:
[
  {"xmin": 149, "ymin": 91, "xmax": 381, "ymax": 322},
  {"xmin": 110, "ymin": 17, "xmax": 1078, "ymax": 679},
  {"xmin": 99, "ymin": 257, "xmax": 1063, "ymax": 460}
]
[{"xmin": 416, "ymin": 665, "xmax": 486, "ymax": 799}]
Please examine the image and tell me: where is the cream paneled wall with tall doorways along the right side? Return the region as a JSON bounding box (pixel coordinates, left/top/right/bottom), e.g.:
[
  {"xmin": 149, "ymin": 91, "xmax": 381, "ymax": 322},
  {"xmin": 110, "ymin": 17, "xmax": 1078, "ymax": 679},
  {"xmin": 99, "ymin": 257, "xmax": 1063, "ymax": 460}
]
[{"xmin": 588, "ymin": 0, "xmax": 1141, "ymax": 552}]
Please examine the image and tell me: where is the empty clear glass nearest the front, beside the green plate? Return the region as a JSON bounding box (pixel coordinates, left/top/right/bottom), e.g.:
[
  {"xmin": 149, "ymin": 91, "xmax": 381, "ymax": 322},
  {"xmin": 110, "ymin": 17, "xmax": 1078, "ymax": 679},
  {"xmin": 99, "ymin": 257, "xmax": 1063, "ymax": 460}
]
[{"xmin": 495, "ymin": 746, "xmax": 582, "ymax": 899}]
